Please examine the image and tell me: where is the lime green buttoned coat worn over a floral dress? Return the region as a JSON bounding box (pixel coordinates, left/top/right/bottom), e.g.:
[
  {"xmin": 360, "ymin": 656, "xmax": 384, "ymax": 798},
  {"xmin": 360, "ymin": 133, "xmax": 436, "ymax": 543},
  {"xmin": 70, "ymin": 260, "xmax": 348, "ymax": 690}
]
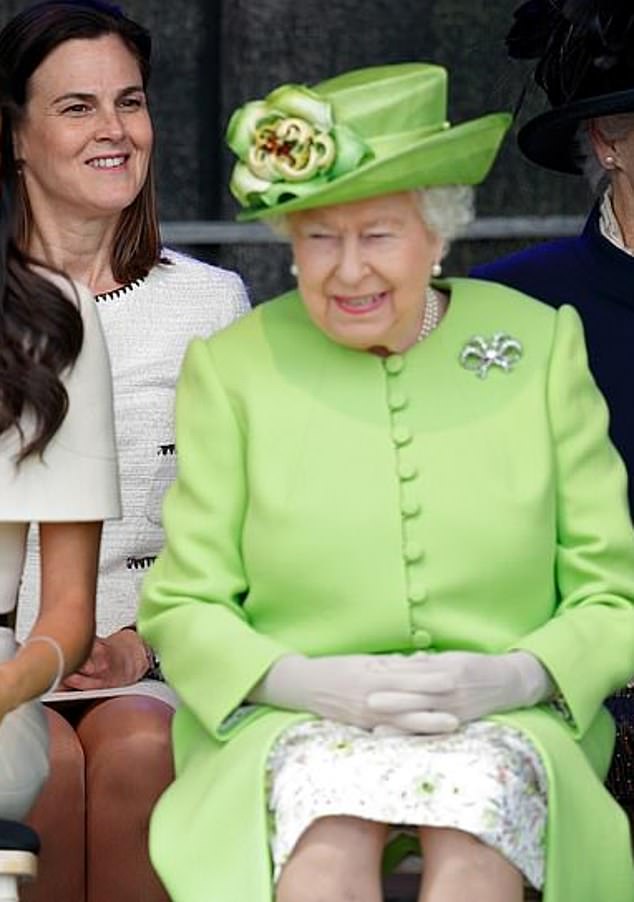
[{"xmin": 140, "ymin": 280, "xmax": 634, "ymax": 902}]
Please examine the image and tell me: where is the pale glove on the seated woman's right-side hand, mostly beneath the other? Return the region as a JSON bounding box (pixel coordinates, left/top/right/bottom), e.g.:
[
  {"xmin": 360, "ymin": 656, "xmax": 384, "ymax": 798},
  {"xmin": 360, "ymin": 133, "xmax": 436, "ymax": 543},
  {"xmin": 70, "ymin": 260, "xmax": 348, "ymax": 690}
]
[{"xmin": 367, "ymin": 651, "xmax": 554, "ymax": 732}]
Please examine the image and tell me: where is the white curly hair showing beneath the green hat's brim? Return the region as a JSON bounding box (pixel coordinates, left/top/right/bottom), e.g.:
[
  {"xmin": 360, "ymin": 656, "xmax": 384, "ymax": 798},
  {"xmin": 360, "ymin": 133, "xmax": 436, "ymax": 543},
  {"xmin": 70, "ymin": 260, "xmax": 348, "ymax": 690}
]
[{"xmin": 264, "ymin": 185, "xmax": 475, "ymax": 254}]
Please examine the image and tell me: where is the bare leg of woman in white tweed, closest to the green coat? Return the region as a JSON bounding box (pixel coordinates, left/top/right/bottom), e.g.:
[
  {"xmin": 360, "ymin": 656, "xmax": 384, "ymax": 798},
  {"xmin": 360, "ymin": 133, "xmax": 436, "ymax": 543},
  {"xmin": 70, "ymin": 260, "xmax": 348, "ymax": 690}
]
[{"xmin": 77, "ymin": 695, "xmax": 173, "ymax": 902}]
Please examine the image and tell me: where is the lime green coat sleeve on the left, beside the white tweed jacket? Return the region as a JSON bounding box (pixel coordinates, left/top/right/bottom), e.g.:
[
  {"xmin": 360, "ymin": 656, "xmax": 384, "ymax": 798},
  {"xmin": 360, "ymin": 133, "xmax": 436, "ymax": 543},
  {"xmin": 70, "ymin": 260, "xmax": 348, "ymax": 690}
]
[{"xmin": 138, "ymin": 339, "xmax": 288, "ymax": 739}]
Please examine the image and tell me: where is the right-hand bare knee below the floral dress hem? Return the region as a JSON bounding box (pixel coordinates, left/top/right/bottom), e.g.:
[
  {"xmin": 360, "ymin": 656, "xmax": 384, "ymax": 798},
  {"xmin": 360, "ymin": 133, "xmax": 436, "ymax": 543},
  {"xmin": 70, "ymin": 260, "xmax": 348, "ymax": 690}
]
[{"xmin": 418, "ymin": 827, "xmax": 523, "ymax": 902}]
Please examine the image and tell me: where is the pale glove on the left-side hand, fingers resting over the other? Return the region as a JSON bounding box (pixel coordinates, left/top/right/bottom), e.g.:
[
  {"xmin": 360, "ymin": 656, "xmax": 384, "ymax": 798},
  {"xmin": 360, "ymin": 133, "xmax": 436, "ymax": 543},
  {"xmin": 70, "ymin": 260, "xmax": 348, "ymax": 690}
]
[{"xmin": 249, "ymin": 654, "xmax": 459, "ymax": 733}]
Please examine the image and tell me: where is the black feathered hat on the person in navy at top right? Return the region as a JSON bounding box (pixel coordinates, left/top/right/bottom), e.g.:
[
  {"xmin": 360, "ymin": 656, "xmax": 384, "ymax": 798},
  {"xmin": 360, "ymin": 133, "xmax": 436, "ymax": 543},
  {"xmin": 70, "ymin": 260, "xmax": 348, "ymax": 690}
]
[{"xmin": 506, "ymin": 0, "xmax": 634, "ymax": 173}]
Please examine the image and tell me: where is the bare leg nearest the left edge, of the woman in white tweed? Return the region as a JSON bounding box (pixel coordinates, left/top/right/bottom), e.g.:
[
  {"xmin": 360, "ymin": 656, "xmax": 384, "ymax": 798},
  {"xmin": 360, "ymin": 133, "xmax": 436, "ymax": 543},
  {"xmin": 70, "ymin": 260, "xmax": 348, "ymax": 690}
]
[{"xmin": 20, "ymin": 708, "xmax": 86, "ymax": 902}]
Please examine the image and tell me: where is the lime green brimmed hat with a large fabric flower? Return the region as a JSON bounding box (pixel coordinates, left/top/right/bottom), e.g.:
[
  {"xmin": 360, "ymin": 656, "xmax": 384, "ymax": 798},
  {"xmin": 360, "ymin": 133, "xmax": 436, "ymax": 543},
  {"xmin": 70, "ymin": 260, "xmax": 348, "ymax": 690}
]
[{"xmin": 227, "ymin": 63, "xmax": 511, "ymax": 219}]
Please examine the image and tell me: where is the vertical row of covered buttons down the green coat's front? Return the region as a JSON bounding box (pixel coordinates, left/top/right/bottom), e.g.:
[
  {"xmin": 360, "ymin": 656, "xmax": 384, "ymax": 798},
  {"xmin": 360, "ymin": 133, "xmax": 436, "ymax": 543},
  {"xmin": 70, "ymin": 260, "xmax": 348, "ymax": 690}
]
[{"xmin": 383, "ymin": 354, "xmax": 432, "ymax": 648}]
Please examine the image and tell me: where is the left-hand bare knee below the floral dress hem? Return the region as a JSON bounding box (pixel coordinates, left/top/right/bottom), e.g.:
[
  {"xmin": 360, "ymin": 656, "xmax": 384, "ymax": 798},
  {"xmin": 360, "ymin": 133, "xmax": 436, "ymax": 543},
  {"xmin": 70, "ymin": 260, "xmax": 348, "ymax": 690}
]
[{"xmin": 276, "ymin": 817, "xmax": 387, "ymax": 902}]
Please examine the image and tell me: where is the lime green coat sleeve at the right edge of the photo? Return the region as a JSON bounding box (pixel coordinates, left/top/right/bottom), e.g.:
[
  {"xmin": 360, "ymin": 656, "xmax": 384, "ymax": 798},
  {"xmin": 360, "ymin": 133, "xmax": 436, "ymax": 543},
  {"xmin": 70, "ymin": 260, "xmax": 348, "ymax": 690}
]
[{"xmin": 514, "ymin": 307, "xmax": 634, "ymax": 738}]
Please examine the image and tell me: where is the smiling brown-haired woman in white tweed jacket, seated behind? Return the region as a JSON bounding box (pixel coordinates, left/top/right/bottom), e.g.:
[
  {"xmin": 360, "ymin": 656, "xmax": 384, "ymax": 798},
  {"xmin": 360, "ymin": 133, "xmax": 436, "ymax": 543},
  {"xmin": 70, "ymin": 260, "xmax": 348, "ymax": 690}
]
[{"xmin": 0, "ymin": 0, "xmax": 248, "ymax": 902}]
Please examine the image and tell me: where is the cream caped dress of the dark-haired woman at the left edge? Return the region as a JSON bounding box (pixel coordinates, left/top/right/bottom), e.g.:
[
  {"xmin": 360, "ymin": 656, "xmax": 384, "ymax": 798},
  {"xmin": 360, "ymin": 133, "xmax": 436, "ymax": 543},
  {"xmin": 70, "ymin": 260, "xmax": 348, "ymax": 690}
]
[{"xmin": 0, "ymin": 277, "xmax": 120, "ymax": 820}]
